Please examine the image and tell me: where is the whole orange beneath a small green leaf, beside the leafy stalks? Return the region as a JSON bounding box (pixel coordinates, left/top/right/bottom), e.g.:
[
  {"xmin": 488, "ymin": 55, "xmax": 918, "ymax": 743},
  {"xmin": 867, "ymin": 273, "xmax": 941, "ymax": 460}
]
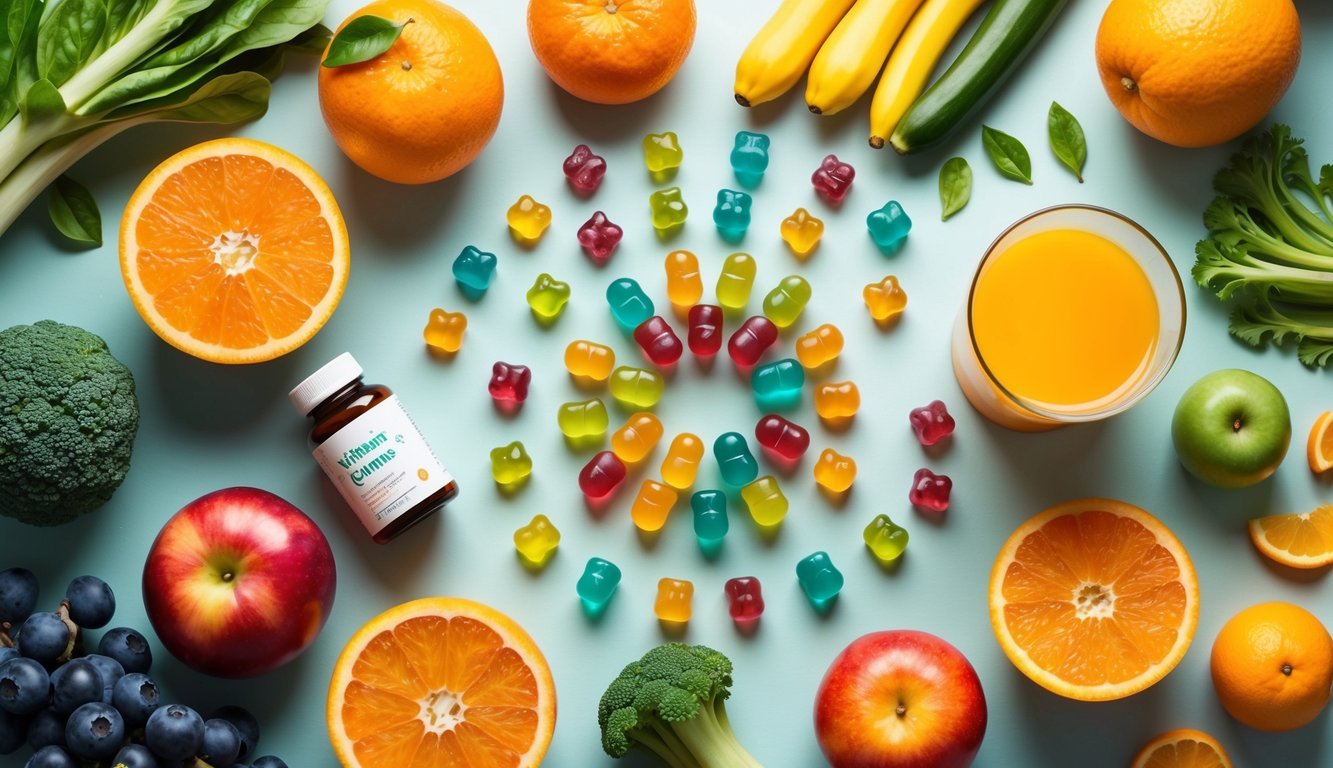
[{"xmin": 319, "ymin": 0, "xmax": 504, "ymax": 184}]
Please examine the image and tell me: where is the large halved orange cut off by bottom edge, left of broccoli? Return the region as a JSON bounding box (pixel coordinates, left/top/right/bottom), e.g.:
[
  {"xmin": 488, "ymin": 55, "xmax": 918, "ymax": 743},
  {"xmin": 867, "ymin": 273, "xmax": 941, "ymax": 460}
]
[{"xmin": 325, "ymin": 597, "xmax": 556, "ymax": 768}]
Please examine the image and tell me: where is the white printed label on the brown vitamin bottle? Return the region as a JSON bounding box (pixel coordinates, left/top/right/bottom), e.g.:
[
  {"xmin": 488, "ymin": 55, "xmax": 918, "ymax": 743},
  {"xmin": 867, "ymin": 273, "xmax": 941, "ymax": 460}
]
[{"xmin": 313, "ymin": 395, "xmax": 453, "ymax": 536}]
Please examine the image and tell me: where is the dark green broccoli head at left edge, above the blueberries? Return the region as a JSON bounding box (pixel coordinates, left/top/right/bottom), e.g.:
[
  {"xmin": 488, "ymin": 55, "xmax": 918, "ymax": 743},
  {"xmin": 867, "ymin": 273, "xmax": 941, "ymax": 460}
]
[{"xmin": 0, "ymin": 320, "xmax": 139, "ymax": 525}]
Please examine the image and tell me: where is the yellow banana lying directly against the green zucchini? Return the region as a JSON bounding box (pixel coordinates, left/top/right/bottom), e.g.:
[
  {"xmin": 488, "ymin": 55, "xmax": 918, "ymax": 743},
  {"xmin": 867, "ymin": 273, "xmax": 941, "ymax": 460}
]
[{"xmin": 870, "ymin": 0, "xmax": 985, "ymax": 149}]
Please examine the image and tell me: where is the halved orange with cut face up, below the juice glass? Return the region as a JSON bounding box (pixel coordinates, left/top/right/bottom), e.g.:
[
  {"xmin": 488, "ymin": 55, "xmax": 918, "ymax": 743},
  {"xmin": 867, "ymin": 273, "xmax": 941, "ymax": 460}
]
[{"xmin": 990, "ymin": 499, "xmax": 1198, "ymax": 701}]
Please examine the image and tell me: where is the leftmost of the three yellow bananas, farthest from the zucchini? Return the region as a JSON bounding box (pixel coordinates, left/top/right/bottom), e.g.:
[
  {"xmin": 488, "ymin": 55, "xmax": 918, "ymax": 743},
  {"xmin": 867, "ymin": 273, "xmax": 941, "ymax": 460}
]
[{"xmin": 736, "ymin": 0, "xmax": 854, "ymax": 107}]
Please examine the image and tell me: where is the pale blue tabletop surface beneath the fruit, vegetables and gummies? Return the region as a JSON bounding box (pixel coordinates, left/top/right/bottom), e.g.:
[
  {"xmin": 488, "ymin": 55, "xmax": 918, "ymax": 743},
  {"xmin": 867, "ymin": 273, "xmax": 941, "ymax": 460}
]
[{"xmin": 0, "ymin": 0, "xmax": 1333, "ymax": 768}]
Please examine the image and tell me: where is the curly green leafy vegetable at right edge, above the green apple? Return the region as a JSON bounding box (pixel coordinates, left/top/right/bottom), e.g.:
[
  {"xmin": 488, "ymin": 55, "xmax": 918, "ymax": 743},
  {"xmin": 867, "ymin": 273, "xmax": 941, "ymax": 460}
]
[{"xmin": 1192, "ymin": 124, "xmax": 1333, "ymax": 367}]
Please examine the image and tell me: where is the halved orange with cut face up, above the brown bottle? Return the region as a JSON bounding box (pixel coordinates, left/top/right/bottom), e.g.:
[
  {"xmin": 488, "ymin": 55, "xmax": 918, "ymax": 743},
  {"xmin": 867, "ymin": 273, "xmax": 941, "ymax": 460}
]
[{"xmin": 120, "ymin": 137, "xmax": 348, "ymax": 363}]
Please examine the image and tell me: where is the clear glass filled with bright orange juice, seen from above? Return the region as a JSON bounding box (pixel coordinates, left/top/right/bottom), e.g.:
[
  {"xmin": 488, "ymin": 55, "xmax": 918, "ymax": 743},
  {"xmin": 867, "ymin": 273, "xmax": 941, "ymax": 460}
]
[{"xmin": 953, "ymin": 205, "xmax": 1185, "ymax": 432}]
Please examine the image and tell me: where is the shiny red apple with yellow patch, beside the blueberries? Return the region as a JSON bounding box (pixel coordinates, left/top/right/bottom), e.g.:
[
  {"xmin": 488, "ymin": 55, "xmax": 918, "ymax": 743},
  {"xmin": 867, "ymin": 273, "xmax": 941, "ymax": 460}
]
[{"xmin": 144, "ymin": 488, "xmax": 336, "ymax": 677}]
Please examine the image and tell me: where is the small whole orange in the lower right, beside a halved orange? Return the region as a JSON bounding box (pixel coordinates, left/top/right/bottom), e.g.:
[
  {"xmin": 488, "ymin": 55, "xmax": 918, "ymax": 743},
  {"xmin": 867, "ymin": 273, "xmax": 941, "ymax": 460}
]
[{"xmin": 1210, "ymin": 603, "xmax": 1333, "ymax": 731}]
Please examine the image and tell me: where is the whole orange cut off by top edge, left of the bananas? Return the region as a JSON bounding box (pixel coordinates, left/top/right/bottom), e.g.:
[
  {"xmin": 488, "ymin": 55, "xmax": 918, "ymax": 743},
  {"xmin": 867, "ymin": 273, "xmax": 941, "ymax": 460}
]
[{"xmin": 528, "ymin": 0, "xmax": 694, "ymax": 104}]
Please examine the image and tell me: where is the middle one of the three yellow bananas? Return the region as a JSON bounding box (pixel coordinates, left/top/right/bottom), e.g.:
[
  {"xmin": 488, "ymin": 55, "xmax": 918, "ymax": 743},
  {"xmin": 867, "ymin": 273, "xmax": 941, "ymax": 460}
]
[{"xmin": 805, "ymin": 0, "xmax": 922, "ymax": 115}]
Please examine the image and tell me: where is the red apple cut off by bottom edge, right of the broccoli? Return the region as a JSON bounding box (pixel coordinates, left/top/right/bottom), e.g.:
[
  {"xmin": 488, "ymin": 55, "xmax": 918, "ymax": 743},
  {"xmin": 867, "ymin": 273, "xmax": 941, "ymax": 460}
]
[{"xmin": 814, "ymin": 629, "xmax": 986, "ymax": 768}]
